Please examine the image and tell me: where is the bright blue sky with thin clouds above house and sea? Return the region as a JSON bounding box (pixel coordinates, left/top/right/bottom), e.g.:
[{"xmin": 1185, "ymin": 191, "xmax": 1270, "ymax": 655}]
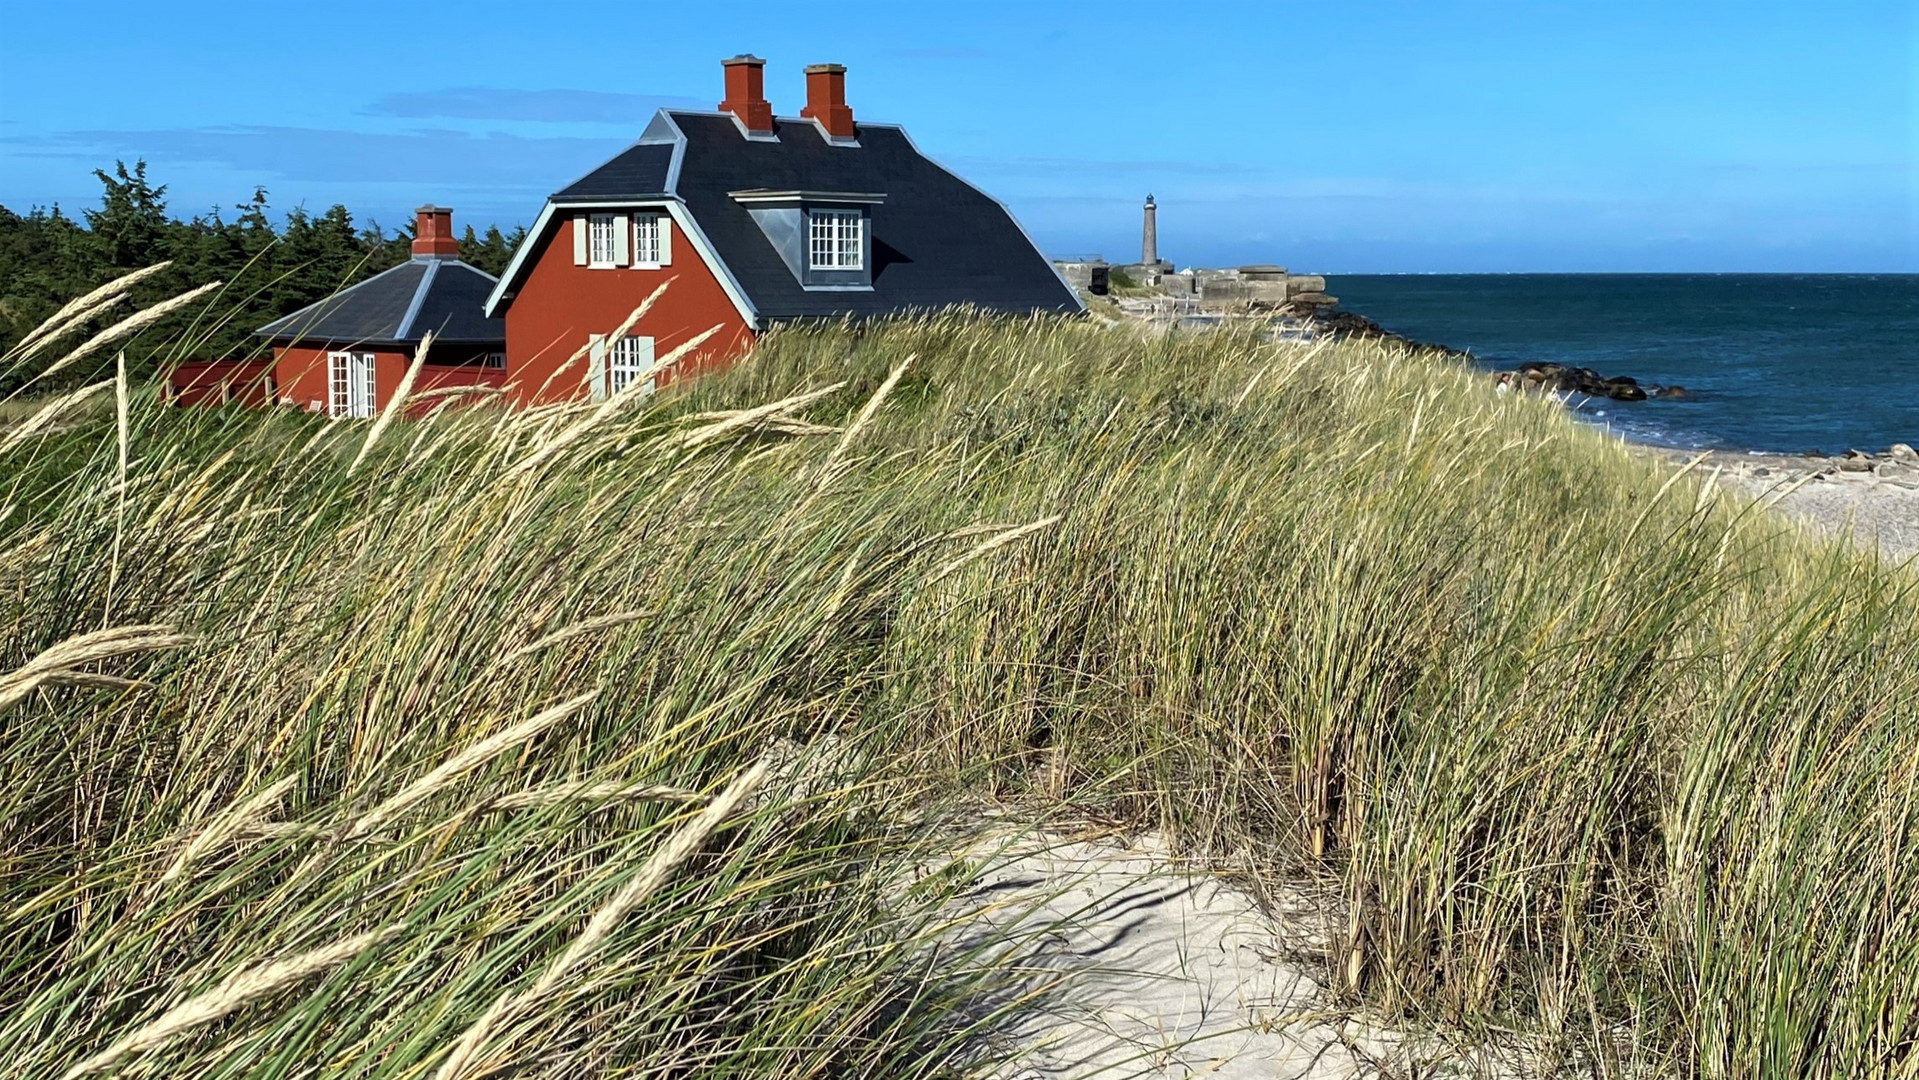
[{"xmin": 0, "ymin": 0, "xmax": 1919, "ymax": 272}]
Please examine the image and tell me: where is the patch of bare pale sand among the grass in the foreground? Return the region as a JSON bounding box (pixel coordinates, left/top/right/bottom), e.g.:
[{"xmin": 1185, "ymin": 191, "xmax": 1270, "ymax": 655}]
[{"xmin": 965, "ymin": 836, "xmax": 1518, "ymax": 1080}]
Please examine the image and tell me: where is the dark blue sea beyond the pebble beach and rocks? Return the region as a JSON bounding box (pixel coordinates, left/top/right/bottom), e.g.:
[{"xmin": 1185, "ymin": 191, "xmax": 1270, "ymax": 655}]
[{"xmin": 1326, "ymin": 274, "xmax": 1919, "ymax": 455}]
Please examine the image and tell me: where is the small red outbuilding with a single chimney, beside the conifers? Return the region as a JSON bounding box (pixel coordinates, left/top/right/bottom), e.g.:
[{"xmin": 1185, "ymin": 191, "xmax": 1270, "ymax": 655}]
[{"xmin": 255, "ymin": 205, "xmax": 507, "ymax": 418}]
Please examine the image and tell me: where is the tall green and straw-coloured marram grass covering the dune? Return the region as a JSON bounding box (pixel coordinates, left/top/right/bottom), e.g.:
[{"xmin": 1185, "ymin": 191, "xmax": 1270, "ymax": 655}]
[{"xmin": 0, "ymin": 306, "xmax": 1919, "ymax": 1078}]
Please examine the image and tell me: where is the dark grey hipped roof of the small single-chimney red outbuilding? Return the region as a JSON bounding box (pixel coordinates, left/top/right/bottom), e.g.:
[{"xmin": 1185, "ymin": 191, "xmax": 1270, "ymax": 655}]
[{"xmin": 253, "ymin": 259, "xmax": 507, "ymax": 345}]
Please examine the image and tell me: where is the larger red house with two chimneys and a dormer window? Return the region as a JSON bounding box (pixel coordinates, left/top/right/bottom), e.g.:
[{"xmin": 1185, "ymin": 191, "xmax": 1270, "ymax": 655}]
[{"xmin": 486, "ymin": 56, "xmax": 1084, "ymax": 403}]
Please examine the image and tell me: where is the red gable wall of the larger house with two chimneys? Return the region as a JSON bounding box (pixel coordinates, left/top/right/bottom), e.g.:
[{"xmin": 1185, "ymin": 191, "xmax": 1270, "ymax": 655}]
[{"xmin": 507, "ymin": 215, "xmax": 752, "ymax": 405}]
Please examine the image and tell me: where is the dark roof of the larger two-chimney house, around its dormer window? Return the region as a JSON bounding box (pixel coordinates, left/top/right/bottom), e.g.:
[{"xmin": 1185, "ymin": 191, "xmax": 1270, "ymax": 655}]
[{"xmin": 533, "ymin": 111, "xmax": 1080, "ymax": 320}]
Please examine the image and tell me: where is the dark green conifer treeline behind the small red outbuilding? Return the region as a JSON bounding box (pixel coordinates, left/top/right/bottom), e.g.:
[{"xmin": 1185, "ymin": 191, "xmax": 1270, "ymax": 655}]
[{"xmin": 0, "ymin": 161, "xmax": 526, "ymax": 393}]
